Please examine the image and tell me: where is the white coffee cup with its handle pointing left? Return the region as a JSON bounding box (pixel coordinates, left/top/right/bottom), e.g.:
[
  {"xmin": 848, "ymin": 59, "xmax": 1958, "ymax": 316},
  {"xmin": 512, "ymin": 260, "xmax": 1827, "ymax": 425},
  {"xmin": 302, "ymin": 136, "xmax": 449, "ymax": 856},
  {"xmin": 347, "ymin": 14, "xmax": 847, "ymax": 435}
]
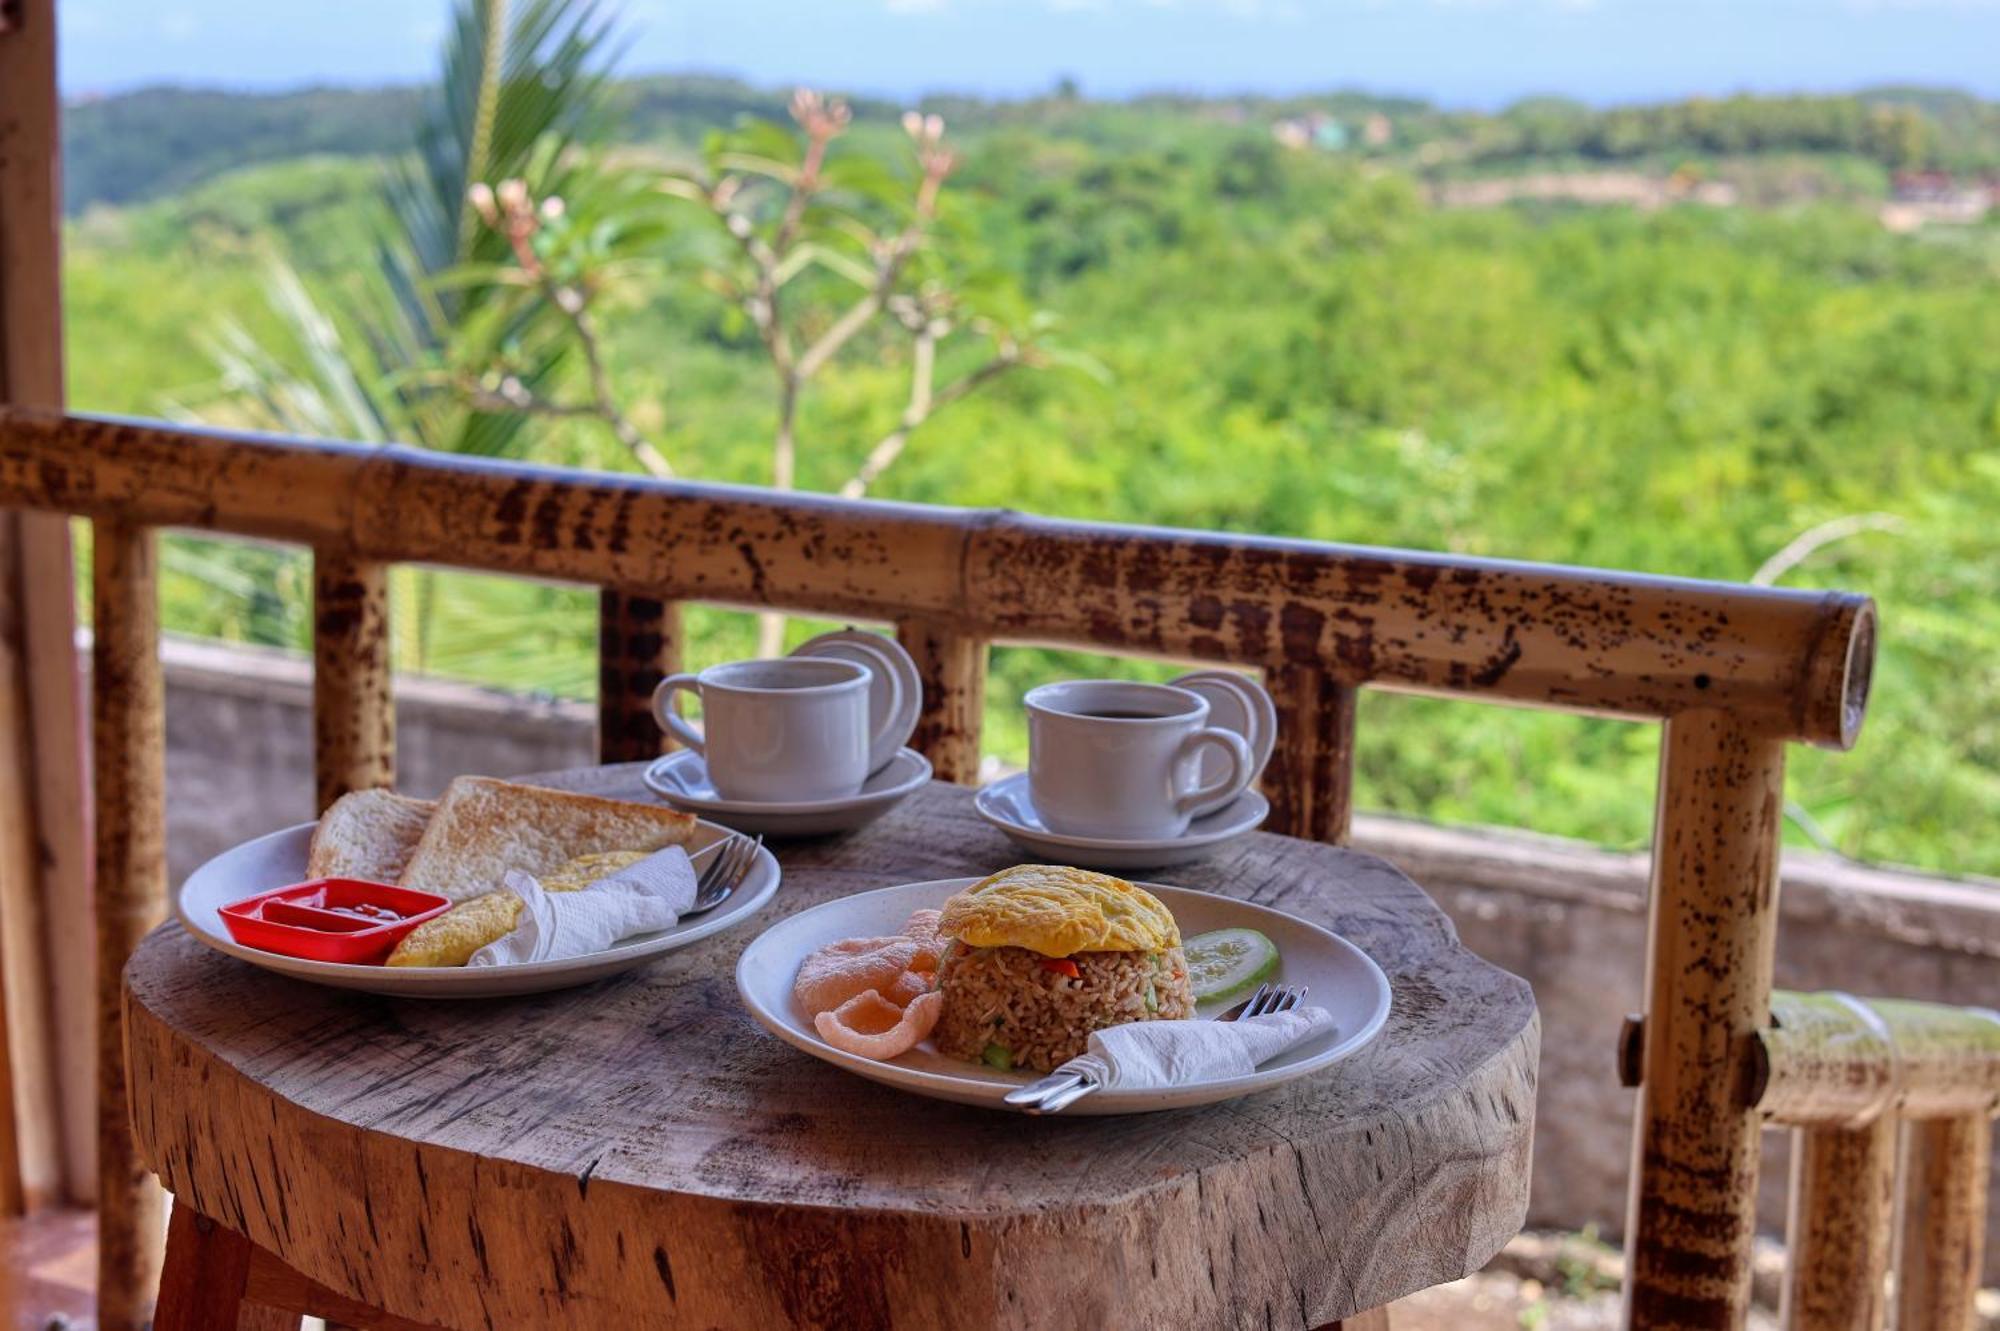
[{"xmin": 652, "ymin": 656, "xmax": 892, "ymax": 803}]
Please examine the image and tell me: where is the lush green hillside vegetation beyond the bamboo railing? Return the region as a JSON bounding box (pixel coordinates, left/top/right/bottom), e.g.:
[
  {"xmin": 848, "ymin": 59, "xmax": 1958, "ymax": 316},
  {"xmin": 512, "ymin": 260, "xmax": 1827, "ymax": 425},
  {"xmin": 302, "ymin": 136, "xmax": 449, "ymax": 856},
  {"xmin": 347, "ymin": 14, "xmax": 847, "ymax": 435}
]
[{"xmin": 68, "ymin": 80, "xmax": 2000, "ymax": 873}]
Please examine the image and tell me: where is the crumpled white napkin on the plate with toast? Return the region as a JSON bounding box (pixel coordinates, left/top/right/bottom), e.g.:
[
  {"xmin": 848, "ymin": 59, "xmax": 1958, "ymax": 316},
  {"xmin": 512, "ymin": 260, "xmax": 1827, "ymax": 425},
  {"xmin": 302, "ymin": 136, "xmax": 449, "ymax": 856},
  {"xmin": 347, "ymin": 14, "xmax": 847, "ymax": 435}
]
[{"xmin": 466, "ymin": 845, "xmax": 694, "ymax": 965}]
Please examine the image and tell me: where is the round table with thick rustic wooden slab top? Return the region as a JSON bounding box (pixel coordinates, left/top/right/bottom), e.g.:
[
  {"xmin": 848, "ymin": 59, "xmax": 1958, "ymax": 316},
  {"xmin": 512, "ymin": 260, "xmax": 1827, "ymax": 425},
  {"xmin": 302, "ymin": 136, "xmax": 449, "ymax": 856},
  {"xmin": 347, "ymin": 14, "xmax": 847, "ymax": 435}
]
[{"xmin": 126, "ymin": 765, "xmax": 1538, "ymax": 1331}]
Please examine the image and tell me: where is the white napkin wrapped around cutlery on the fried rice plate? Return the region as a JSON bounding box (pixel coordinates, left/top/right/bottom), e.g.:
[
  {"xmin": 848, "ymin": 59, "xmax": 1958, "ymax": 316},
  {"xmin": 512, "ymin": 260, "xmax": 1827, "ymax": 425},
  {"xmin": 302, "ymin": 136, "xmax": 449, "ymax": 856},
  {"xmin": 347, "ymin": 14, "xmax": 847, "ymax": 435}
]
[{"xmin": 1056, "ymin": 1007, "xmax": 1334, "ymax": 1091}]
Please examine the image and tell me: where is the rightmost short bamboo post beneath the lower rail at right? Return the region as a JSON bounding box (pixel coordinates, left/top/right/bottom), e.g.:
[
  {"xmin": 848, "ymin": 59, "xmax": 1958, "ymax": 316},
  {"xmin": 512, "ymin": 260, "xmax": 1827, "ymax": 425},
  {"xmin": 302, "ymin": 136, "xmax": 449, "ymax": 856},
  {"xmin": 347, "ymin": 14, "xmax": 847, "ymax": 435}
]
[{"xmin": 1896, "ymin": 1113, "xmax": 1992, "ymax": 1331}]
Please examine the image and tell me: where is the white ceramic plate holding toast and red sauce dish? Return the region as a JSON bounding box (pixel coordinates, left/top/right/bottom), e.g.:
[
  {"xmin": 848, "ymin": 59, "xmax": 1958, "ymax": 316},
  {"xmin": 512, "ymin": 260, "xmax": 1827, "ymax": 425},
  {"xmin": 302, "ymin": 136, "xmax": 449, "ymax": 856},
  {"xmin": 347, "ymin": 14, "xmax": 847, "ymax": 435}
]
[{"xmin": 174, "ymin": 821, "xmax": 778, "ymax": 997}]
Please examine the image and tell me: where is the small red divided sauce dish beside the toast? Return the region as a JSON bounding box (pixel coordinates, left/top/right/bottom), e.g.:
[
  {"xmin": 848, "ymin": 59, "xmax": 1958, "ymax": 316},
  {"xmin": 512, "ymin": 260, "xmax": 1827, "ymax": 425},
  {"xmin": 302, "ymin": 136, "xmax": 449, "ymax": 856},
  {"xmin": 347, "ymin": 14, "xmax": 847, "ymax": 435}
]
[{"xmin": 222, "ymin": 877, "xmax": 452, "ymax": 965}]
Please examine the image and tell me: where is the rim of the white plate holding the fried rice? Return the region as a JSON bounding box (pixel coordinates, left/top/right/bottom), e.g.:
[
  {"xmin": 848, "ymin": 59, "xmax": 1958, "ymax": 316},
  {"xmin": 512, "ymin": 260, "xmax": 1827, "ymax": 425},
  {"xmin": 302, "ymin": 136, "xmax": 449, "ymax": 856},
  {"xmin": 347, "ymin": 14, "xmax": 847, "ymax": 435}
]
[{"xmin": 736, "ymin": 877, "xmax": 1396, "ymax": 1113}]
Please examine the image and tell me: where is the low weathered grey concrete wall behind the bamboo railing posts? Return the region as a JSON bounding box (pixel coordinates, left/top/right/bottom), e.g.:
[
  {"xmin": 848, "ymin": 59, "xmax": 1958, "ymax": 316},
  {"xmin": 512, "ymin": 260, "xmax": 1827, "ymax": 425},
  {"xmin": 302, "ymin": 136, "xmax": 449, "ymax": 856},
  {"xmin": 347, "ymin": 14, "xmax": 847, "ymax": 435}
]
[{"xmin": 166, "ymin": 642, "xmax": 2000, "ymax": 1279}]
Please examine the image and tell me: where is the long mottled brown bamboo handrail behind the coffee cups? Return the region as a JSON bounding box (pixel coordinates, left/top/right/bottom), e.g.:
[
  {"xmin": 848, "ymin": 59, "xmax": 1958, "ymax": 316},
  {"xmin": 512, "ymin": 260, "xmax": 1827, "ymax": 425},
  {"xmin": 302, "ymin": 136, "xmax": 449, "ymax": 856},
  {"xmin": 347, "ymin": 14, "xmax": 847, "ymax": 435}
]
[{"xmin": 0, "ymin": 408, "xmax": 1874, "ymax": 747}]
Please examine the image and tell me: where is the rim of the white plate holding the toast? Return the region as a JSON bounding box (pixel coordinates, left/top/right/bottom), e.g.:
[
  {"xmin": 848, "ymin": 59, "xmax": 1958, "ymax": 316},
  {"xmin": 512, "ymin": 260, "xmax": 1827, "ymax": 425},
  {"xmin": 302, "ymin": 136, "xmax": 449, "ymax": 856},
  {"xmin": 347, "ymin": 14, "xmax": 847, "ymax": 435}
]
[{"xmin": 174, "ymin": 817, "xmax": 784, "ymax": 993}]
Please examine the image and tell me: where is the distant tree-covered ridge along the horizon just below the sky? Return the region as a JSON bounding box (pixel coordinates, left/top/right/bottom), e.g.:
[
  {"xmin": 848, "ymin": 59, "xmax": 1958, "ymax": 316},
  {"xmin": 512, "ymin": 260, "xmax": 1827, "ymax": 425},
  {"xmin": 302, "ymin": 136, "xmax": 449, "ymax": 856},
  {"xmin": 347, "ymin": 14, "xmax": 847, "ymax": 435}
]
[{"xmin": 62, "ymin": 74, "xmax": 2000, "ymax": 214}]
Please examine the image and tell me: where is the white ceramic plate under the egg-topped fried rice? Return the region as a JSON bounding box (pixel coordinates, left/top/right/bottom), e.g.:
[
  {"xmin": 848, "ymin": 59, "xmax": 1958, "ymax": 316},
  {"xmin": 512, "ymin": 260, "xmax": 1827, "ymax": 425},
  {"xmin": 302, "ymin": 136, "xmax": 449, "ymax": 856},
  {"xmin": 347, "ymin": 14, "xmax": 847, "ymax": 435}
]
[{"xmin": 736, "ymin": 877, "xmax": 1390, "ymax": 1113}]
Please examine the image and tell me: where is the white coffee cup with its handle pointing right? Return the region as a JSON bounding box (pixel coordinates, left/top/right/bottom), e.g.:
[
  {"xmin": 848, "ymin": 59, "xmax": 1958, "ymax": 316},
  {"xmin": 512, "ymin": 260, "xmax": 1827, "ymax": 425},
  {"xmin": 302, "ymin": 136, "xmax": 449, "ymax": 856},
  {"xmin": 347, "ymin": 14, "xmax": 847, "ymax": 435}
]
[{"xmin": 1026, "ymin": 679, "xmax": 1256, "ymax": 841}]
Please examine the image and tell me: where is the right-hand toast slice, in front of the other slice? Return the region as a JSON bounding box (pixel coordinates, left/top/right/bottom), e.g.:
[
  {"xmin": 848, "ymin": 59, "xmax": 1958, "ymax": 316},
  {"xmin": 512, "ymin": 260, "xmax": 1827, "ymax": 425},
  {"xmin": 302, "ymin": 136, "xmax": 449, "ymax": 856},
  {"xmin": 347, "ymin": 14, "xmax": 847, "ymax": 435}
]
[{"xmin": 402, "ymin": 777, "xmax": 696, "ymax": 901}]
